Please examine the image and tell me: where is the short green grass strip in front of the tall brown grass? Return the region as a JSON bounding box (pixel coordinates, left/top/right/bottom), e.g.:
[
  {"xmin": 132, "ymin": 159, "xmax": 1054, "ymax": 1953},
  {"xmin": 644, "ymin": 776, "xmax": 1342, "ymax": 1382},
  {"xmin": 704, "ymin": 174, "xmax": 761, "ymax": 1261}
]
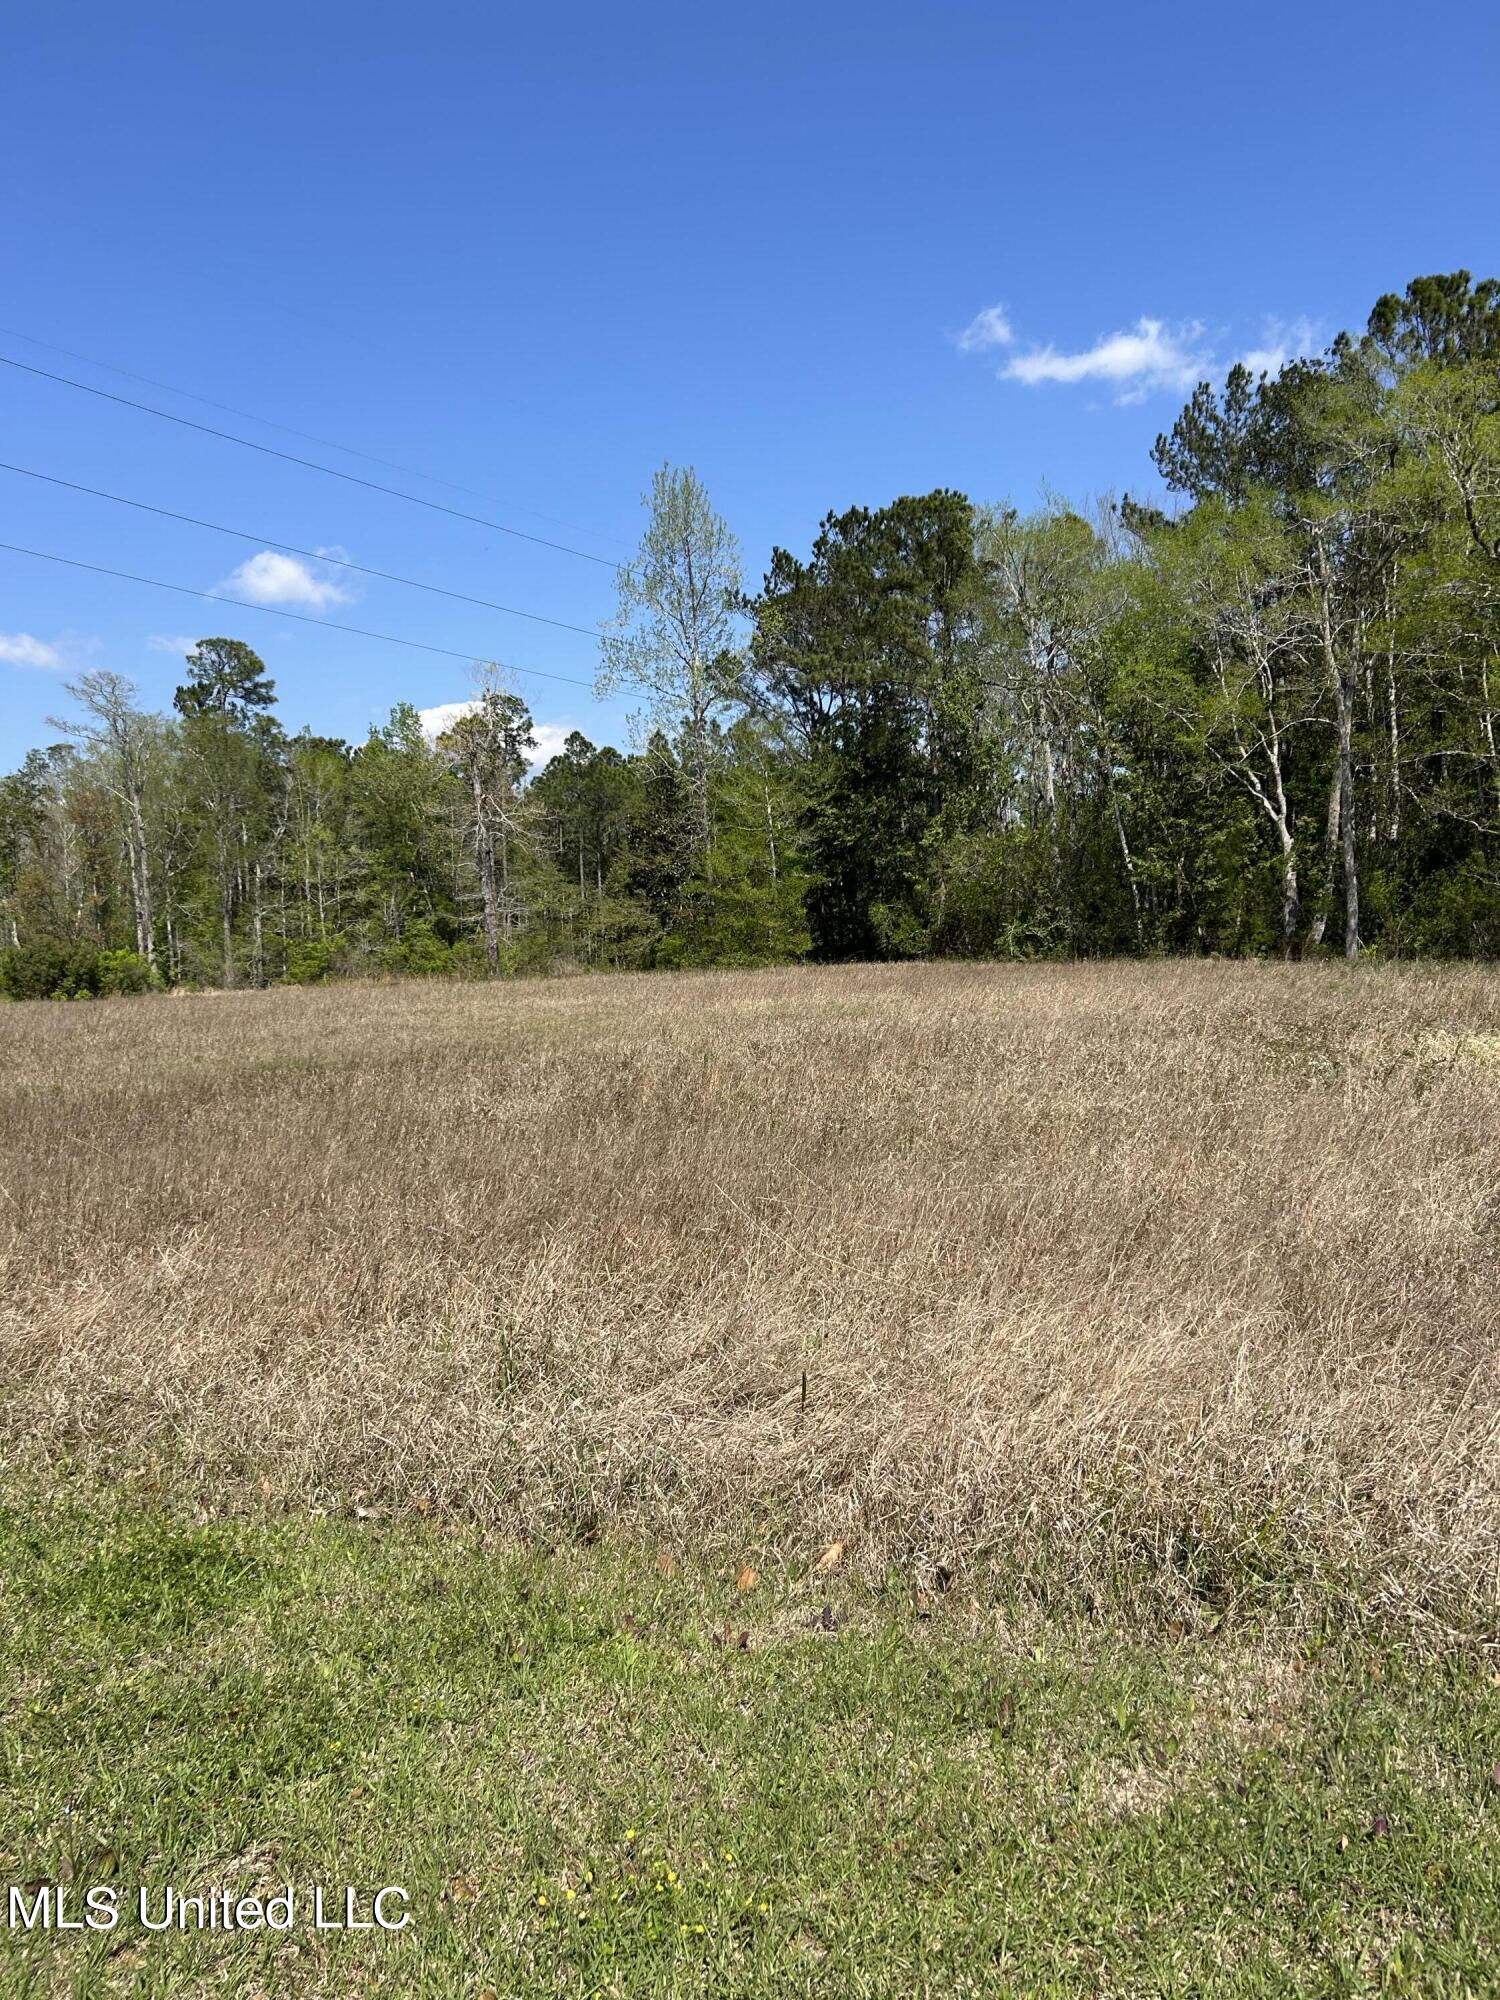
[{"xmin": 0, "ymin": 1486, "xmax": 1500, "ymax": 2000}]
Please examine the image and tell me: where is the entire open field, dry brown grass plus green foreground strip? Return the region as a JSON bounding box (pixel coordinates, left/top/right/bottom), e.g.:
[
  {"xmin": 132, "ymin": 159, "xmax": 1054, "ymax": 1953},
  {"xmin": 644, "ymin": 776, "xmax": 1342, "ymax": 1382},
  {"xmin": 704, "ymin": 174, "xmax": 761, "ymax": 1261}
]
[{"xmin": 0, "ymin": 964, "xmax": 1500, "ymax": 1996}]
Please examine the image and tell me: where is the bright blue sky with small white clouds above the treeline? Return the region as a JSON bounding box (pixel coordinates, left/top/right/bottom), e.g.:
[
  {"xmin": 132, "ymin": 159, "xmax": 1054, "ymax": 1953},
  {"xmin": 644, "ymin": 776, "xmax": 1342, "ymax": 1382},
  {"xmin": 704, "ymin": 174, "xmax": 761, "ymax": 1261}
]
[{"xmin": 0, "ymin": 0, "xmax": 1500, "ymax": 768}]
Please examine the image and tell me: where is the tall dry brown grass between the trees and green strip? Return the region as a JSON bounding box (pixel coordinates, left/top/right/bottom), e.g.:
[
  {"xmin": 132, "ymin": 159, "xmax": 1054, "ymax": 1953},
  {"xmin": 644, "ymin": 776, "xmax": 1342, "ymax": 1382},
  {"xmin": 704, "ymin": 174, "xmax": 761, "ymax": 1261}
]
[{"xmin": 0, "ymin": 964, "xmax": 1500, "ymax": 1630}]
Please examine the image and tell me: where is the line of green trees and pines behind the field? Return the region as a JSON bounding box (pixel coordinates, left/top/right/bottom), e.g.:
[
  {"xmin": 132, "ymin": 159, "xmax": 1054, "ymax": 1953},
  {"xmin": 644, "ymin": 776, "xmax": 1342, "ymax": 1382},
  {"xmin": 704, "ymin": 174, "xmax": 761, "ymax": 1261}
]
[{"xmin": 0, "ymin": 272, "xmax": 1500, "ymax": 998}]
